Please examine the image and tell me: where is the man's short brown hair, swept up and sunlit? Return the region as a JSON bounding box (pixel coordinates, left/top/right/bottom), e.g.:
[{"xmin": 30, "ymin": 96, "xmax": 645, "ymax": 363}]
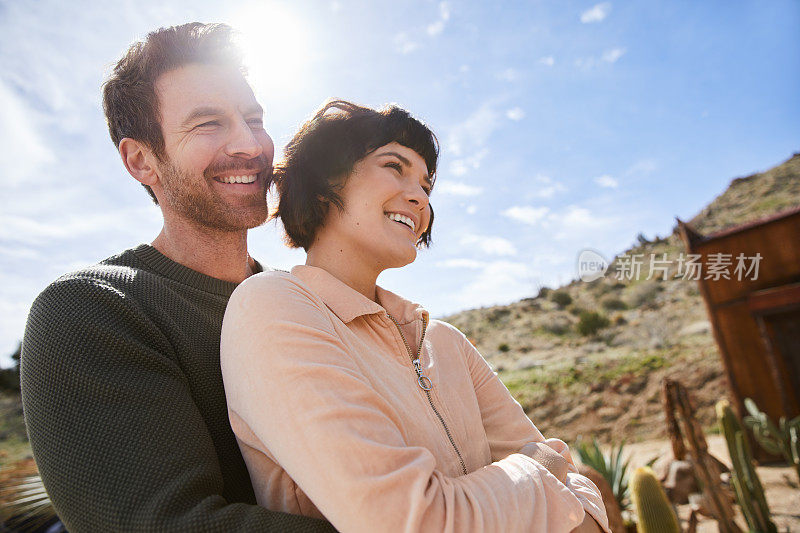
[{"xmin": 103, "ymin": 22, "xmax": 245, "ymax": 204}]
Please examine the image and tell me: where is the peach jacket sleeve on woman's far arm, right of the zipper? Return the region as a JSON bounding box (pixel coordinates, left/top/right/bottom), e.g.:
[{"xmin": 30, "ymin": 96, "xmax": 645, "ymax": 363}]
[{"xmin": 450, "ymin": 326, "xmax": 611, "ymax": 532}]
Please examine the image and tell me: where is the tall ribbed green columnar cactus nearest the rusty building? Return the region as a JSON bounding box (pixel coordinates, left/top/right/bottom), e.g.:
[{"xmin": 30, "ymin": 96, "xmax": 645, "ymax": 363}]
[{"xmin": 717, "ymin": 400, "xmax": 778, "ymax": 533}]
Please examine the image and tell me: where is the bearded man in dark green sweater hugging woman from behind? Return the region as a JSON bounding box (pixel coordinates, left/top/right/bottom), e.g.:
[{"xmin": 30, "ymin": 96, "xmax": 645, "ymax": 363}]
[{"xmin": 21, "ymin": 23, "xmax": 333, "ymax": 532}]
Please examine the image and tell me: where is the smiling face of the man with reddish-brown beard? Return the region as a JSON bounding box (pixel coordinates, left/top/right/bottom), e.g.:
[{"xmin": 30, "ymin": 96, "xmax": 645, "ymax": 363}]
[{"xmin": 153, "ymin": 64, "xmax": 275, "ymax": 231}]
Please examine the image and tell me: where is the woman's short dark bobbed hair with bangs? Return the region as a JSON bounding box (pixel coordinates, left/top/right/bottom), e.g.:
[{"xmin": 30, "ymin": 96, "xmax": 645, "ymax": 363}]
[{"xmin": 273, "ymin": 100, "xmax": 439, "ymax": 251}]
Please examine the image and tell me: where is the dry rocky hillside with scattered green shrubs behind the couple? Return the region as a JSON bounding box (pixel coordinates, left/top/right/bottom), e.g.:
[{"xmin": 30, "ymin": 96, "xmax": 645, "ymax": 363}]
[{"xmin": 444, "ymin": 154, "xmax": 800, "ymax": 442}]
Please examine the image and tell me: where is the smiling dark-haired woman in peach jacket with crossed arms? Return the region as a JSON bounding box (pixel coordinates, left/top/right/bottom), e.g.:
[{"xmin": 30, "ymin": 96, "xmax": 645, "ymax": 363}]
[{"xmin": 221, "ymin": 101, "xmax": 607, "ymax": 532}]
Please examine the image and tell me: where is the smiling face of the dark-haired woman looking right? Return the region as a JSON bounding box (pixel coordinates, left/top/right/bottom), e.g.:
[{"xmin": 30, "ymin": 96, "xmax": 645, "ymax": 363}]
[{"xmin": 317, "ymin": 142, "xmax": 431, "ymax": 273}]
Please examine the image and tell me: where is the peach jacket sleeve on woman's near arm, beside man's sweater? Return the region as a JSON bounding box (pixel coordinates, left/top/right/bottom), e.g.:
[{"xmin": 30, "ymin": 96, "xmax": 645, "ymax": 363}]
[{"xmin": 221, "ymin": 276, "xmax": 584, "ymax": 533}]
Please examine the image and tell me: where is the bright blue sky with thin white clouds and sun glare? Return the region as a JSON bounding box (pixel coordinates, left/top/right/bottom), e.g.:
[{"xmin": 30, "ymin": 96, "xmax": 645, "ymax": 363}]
[{"xmin": 0, "ymin": 0, "xmax": 800, "ymax": 366}]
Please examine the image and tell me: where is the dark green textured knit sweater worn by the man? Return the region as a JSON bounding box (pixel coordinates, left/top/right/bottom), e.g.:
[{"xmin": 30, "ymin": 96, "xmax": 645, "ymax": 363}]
[{"xmin": 21, "ymin": 245, "xmax": 334, "ymax": 533}]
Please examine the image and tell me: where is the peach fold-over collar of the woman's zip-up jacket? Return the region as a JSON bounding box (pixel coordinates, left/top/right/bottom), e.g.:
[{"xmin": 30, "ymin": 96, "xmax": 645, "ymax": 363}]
[{"xmin": 292, "ymin": 265, "xmax": 428, "ymax": 324}]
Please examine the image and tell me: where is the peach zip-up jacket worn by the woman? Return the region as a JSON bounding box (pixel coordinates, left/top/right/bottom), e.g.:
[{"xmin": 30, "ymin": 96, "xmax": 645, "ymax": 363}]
[{"xmin": 221, "ymin": 266, "xmax": 609, "ymax": 533}]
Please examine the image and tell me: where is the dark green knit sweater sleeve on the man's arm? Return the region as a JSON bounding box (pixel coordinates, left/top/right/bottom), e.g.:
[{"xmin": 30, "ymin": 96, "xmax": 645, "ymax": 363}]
[{"xmin": 21, "ymin": 278, "xmax": 332, "ymax": 532}]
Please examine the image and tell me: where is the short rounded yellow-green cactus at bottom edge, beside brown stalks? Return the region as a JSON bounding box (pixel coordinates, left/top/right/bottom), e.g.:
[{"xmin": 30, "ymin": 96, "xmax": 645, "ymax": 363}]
[{"xmin": 631, "ymin": 466, "xmax": 681, "ymax": 533}]
